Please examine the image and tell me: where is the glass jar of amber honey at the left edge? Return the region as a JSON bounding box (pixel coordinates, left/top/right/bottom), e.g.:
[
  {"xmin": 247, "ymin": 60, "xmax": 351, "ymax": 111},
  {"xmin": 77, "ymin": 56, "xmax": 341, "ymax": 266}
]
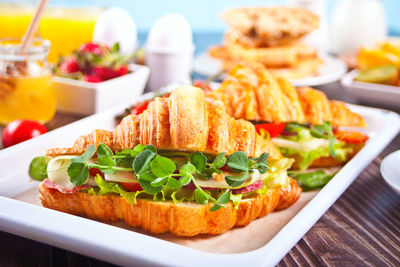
[{"xmin": 0, "ymin": 38, "xmax": 57, "ymax": 124}]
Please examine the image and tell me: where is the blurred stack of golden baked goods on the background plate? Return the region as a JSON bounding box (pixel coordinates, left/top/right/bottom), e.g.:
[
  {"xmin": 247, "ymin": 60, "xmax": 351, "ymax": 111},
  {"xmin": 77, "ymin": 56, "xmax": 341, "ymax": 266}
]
[{"xmin": 209, "ymin": 7, "xmax": 322, "ymax": 79}]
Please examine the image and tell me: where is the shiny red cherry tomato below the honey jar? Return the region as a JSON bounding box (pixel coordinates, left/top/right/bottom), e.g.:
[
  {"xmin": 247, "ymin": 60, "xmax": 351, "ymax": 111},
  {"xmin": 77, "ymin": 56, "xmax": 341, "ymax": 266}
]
[{"xmin": 2, "ymin": 120, "xmax": 47, "ymax": 147}]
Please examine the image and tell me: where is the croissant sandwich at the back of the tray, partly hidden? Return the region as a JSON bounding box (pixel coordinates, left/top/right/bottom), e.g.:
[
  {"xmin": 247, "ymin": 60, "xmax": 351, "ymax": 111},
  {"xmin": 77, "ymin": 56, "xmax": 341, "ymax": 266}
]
[{"xmin": 207, "ymin": 64, "xmax": 368, "ymax": 170}]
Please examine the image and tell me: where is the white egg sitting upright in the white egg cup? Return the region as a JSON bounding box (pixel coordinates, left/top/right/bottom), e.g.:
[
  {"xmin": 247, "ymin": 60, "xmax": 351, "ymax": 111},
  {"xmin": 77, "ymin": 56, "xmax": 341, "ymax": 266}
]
[{"xmin": 146, "ymin": 14, "xmax": 194, "ymax": 52}]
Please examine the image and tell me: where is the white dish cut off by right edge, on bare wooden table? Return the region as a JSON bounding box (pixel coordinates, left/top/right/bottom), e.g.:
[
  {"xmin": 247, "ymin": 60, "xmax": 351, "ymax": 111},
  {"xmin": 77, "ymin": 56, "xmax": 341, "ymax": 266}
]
[{"xmin": 381, "ymin": 150, "xmax": 400, "ymax": 195}]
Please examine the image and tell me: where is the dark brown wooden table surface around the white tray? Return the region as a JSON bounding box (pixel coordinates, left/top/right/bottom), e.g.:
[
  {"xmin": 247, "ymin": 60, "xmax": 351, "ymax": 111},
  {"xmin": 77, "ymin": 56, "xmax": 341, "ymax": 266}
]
[{"xmin": 0, "ymin": 84, "xmax": 400, "ymax": 266}]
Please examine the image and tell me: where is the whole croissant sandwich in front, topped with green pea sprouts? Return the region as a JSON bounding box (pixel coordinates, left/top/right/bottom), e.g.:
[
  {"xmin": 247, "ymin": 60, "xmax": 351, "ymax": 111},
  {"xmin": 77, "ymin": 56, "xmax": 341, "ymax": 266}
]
[{"xmin": 30, "ymin": 86, "xmax": 302, "ymax": 236}]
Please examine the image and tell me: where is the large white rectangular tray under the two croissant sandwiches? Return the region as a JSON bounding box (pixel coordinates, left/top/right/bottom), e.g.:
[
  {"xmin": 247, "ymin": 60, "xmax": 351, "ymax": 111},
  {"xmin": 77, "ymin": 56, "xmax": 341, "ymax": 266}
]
[{"xmin": 0, "ymin": 96, "xmax": 400, "ymax": 266}]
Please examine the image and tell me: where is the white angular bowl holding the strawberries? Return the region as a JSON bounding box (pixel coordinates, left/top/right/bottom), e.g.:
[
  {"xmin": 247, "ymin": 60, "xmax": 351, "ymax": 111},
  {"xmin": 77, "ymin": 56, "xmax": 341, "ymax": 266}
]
[{"xmin": 53, "ymin": 64, "xmax": 150, "ymax": 115}]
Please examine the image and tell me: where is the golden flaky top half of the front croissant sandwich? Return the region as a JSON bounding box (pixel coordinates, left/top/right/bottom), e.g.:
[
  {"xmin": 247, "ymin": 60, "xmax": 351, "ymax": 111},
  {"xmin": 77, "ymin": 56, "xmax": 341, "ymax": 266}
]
[{"xmin": 47, "ymin": 86, "xmax": 282, "ymax": 160}]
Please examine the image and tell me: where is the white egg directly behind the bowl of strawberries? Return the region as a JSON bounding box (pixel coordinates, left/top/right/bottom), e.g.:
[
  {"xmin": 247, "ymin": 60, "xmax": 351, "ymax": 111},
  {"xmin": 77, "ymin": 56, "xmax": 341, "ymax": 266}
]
[{"xmin": 93, "ymin": 7, "xmax": 137, "ymax": 54}]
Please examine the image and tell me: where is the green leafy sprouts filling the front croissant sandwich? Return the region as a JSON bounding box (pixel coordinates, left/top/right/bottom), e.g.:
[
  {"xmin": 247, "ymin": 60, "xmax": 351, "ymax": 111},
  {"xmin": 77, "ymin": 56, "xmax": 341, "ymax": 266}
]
[{"xmin": 61, "ymin": 143, "xmax": 269, "ymax": 211}]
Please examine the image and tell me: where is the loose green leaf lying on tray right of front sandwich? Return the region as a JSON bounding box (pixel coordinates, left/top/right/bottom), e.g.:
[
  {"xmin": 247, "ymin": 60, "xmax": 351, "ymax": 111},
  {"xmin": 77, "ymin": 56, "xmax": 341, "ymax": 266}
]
[{"xmin": 288, "ymin": 170, "xmax": 334, "ymax": 191}]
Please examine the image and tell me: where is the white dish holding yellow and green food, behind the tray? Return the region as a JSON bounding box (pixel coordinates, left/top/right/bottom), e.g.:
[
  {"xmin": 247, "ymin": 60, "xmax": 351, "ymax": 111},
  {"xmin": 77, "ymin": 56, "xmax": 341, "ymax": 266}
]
[{"xmin": 340, "ymin": 70, "xmax": 400, "ymax": 107}]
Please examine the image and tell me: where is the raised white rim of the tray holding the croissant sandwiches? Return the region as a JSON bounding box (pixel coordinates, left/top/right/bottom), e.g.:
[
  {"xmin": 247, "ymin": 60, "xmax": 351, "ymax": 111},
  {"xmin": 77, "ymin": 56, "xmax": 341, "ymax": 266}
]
[{"xmin": 0, "ymin": 101, "xmax": 400, "ymax": 266}]
